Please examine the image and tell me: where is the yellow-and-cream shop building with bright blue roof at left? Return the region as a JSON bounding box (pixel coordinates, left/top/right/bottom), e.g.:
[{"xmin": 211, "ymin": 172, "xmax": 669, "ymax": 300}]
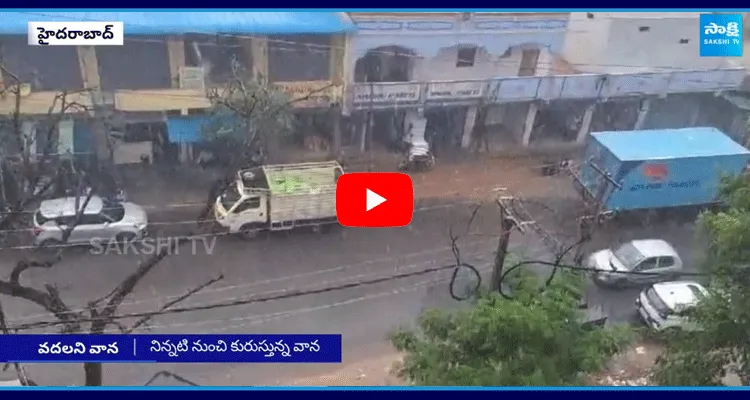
[{"xmin": 0, "ymin": 12, "xmax": 355, "ymax": 163}]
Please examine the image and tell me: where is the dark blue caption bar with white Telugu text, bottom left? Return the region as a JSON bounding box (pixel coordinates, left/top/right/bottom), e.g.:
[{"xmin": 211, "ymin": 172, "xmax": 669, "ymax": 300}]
[{"xmin": 0, "ymin": 334, "xmax": 342, "ymax": 363}]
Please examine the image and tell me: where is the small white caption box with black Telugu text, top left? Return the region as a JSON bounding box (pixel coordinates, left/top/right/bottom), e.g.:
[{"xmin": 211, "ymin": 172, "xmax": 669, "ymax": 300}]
[{"xmin": 29, "ymin": 21, "xmax": 125, "ymax": 46}]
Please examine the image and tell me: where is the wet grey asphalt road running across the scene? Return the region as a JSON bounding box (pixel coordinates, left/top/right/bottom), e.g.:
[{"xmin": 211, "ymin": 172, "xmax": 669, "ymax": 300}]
[{"xmin": 3, "ymin": 158, "xmax": 692, "ymax": 385}]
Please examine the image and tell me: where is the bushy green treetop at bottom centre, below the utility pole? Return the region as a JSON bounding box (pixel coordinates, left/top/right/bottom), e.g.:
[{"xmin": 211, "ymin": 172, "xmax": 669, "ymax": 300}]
[{"xmin": 392, "ymin": 273, "xmax": 629, "ymax": 386}]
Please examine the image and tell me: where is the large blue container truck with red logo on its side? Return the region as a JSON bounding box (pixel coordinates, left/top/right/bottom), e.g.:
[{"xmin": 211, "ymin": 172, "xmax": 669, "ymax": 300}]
[{"xmin": 574, "ymin": 128, "xmax": 750, "ymax": 213}]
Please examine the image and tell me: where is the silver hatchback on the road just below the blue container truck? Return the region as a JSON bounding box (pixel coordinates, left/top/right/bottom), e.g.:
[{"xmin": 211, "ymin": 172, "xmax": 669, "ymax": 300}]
[{"xmin": 587, "ymin": 239, "xmax": 683, "ymax": 287}]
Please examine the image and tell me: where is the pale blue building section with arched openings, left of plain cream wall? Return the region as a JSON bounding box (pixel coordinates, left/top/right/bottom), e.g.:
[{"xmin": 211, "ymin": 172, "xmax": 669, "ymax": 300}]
[{"xmin": 347, "ymin": 13, "xmax": 568, "ymax": 153}]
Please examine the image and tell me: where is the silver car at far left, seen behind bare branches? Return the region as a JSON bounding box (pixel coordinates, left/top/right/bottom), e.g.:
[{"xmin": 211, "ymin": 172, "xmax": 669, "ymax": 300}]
[{"xmin": 33, "ymin": 196, "xmax": 148, "ymax": 246}]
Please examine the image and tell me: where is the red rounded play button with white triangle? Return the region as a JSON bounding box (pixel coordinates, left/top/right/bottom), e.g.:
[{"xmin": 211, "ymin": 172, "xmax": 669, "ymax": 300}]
[{"xmin": 336, "ymin": 172, "xmax": 414, "ymax": 228}]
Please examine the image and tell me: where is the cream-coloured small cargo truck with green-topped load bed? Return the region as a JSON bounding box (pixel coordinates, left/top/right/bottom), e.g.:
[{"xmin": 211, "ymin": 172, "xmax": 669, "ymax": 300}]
[{"xmin": 214, "ymin": 161, "xmax": 344, "ymax": 239}]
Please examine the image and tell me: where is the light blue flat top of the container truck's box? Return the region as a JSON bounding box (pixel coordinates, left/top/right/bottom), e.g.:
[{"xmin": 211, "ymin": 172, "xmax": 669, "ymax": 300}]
[{"xmin": 591, "ymin": 128, "xmax": 750, "ymax": 161}]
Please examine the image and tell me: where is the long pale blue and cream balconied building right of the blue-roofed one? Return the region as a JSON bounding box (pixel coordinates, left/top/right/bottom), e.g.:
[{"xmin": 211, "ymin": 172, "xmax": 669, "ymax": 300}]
[{"xmin": 349, "ymin": 13, "xmax": 746, "ymax": 152}]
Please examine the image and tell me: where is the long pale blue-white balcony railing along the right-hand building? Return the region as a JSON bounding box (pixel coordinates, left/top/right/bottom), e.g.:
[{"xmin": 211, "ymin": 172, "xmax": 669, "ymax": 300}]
[{"xmin": 346, "ymin": 68, "xmax": 746, "ymax": 110}]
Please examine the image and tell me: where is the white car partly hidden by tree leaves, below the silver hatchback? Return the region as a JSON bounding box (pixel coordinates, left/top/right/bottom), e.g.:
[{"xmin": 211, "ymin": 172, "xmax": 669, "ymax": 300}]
[{"xmin": 635, "ymin": 281, "xmax": 708, "ymax": 330}]
